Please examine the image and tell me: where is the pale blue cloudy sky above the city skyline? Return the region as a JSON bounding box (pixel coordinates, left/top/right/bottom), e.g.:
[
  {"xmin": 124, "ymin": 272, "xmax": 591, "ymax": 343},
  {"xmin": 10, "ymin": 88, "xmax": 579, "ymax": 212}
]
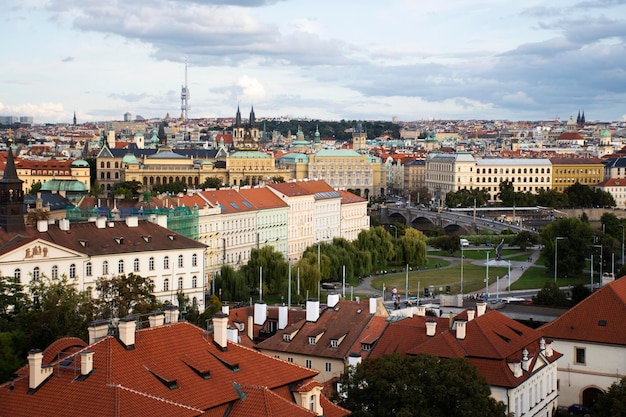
[{"xmin": 0, "ymin": 0, "xmax": 626, "ymax": 123}]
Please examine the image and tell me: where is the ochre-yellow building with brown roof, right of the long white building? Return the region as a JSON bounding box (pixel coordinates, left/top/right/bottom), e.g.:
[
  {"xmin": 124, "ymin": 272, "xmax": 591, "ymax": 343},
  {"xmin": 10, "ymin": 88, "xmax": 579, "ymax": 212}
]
[{"xmin": 550, "ymin": 158, "xmax": 604, "ymax": 192}]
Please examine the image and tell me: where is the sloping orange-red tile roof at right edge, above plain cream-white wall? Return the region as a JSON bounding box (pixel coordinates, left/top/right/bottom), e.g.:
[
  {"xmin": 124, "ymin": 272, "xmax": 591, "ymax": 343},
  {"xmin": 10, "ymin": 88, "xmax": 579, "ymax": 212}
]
[{"xmin": 538, "ymin": 277, "xmax": 626, "ymax": 346}]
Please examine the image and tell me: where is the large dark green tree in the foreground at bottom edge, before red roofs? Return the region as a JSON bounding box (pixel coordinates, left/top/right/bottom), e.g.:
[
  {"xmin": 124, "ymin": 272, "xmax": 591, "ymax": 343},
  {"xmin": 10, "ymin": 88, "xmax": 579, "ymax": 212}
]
[{"xmin": 340, "ymin": 353, "xmax": 506, "ymax": 417}]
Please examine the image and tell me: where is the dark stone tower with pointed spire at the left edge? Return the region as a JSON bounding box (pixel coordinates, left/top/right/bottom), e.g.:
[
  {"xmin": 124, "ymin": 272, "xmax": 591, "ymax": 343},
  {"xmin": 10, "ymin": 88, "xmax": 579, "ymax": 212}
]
[{"xmin": 0, "ymin": 142, "xmax": 24, "ymax": 233}]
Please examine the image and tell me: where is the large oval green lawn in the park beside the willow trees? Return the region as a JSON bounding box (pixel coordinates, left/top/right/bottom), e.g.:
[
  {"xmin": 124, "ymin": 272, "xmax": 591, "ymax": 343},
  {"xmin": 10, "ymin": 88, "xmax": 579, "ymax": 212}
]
[{"xmin": 372, "ymin": 258, "xmax": 508, "ymax": 297}]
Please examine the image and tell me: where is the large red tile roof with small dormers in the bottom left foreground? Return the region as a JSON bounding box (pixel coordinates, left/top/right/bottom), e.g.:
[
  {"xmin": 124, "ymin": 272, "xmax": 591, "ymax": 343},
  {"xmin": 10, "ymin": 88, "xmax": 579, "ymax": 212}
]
[{"xmin": 0, "ymin": 322, "xmax": 348, "ymax": 417}]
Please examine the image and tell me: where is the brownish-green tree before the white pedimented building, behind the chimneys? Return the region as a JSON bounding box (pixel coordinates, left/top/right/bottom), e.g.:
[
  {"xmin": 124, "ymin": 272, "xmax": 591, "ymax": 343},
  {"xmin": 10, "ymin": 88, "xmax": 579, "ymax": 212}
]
[{"xmin": 94, "ymin": 272, "xmax": 161, "ymax": 319}]
